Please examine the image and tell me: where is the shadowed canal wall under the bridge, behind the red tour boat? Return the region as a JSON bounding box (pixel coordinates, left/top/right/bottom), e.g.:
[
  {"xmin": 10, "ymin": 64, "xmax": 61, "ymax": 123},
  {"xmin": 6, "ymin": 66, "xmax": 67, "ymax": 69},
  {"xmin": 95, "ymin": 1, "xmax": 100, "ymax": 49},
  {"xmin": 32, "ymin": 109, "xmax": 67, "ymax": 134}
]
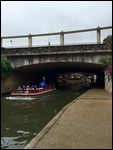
[{"xmin": 1, "ymin": 71, "xmax": 39, "ymax": 94}]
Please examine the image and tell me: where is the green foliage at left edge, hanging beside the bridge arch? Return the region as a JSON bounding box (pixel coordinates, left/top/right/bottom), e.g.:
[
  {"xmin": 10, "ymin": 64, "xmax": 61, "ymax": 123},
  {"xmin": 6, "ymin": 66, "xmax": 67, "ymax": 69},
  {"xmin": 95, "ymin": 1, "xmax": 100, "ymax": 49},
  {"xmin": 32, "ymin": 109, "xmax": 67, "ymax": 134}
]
[{"xmin": 1, "ymin": 58, "xmax": 12, "ymax": 78}]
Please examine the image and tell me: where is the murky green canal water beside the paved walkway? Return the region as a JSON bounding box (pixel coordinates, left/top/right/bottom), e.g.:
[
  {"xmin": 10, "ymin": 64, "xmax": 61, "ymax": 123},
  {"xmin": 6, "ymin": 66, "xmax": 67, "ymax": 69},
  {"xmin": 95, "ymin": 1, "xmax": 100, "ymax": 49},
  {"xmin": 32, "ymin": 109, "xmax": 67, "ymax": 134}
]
[{"xmin": 1, "ymin": 88, "xmax": 88, "ymax": 149}]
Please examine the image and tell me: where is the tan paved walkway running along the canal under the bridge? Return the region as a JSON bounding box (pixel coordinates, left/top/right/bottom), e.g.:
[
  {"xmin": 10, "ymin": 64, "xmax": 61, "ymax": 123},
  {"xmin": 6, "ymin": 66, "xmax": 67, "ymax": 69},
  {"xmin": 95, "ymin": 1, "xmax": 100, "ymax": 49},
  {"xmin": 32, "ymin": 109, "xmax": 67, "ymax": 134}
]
[{"xmin": 25, "ymin": 89, "xmax": 112, "ymax": 149}]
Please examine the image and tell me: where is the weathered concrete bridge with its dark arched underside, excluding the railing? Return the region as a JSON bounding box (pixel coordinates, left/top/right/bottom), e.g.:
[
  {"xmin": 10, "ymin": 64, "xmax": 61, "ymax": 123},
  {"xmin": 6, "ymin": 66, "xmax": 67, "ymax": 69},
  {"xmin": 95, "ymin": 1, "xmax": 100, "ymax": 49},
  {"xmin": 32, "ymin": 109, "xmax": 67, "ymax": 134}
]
[{"xmin": 1, "ymin": 44, "xmax": 112, "ymax": 89}]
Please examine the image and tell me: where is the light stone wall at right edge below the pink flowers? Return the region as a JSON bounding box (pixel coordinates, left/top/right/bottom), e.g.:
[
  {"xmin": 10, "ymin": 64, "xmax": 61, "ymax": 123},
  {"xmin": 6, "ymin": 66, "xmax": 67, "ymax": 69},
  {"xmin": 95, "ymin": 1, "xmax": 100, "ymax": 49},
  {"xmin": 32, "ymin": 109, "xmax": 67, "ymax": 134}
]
[{"xmin": 105, "ymin": 73, "xmax": 112, "ymax": 93}]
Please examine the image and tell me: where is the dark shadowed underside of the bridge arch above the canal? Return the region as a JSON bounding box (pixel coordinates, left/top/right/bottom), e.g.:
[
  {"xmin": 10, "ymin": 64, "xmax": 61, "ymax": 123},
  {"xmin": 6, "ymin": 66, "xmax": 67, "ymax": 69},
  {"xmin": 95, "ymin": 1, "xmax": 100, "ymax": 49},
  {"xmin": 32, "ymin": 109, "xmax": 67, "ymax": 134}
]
[{"xmin": 14, "ymin": 62, "xmax": 104, "ymax": 86}]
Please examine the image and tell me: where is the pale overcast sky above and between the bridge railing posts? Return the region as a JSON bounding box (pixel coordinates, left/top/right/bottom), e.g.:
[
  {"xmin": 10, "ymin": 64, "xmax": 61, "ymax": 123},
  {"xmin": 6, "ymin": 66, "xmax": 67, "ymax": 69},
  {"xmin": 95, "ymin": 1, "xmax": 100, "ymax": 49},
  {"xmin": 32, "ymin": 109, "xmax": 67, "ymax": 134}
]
[{"xmin": 1, "ymin": 1, "xmax": 112, "ymax": 47}]
